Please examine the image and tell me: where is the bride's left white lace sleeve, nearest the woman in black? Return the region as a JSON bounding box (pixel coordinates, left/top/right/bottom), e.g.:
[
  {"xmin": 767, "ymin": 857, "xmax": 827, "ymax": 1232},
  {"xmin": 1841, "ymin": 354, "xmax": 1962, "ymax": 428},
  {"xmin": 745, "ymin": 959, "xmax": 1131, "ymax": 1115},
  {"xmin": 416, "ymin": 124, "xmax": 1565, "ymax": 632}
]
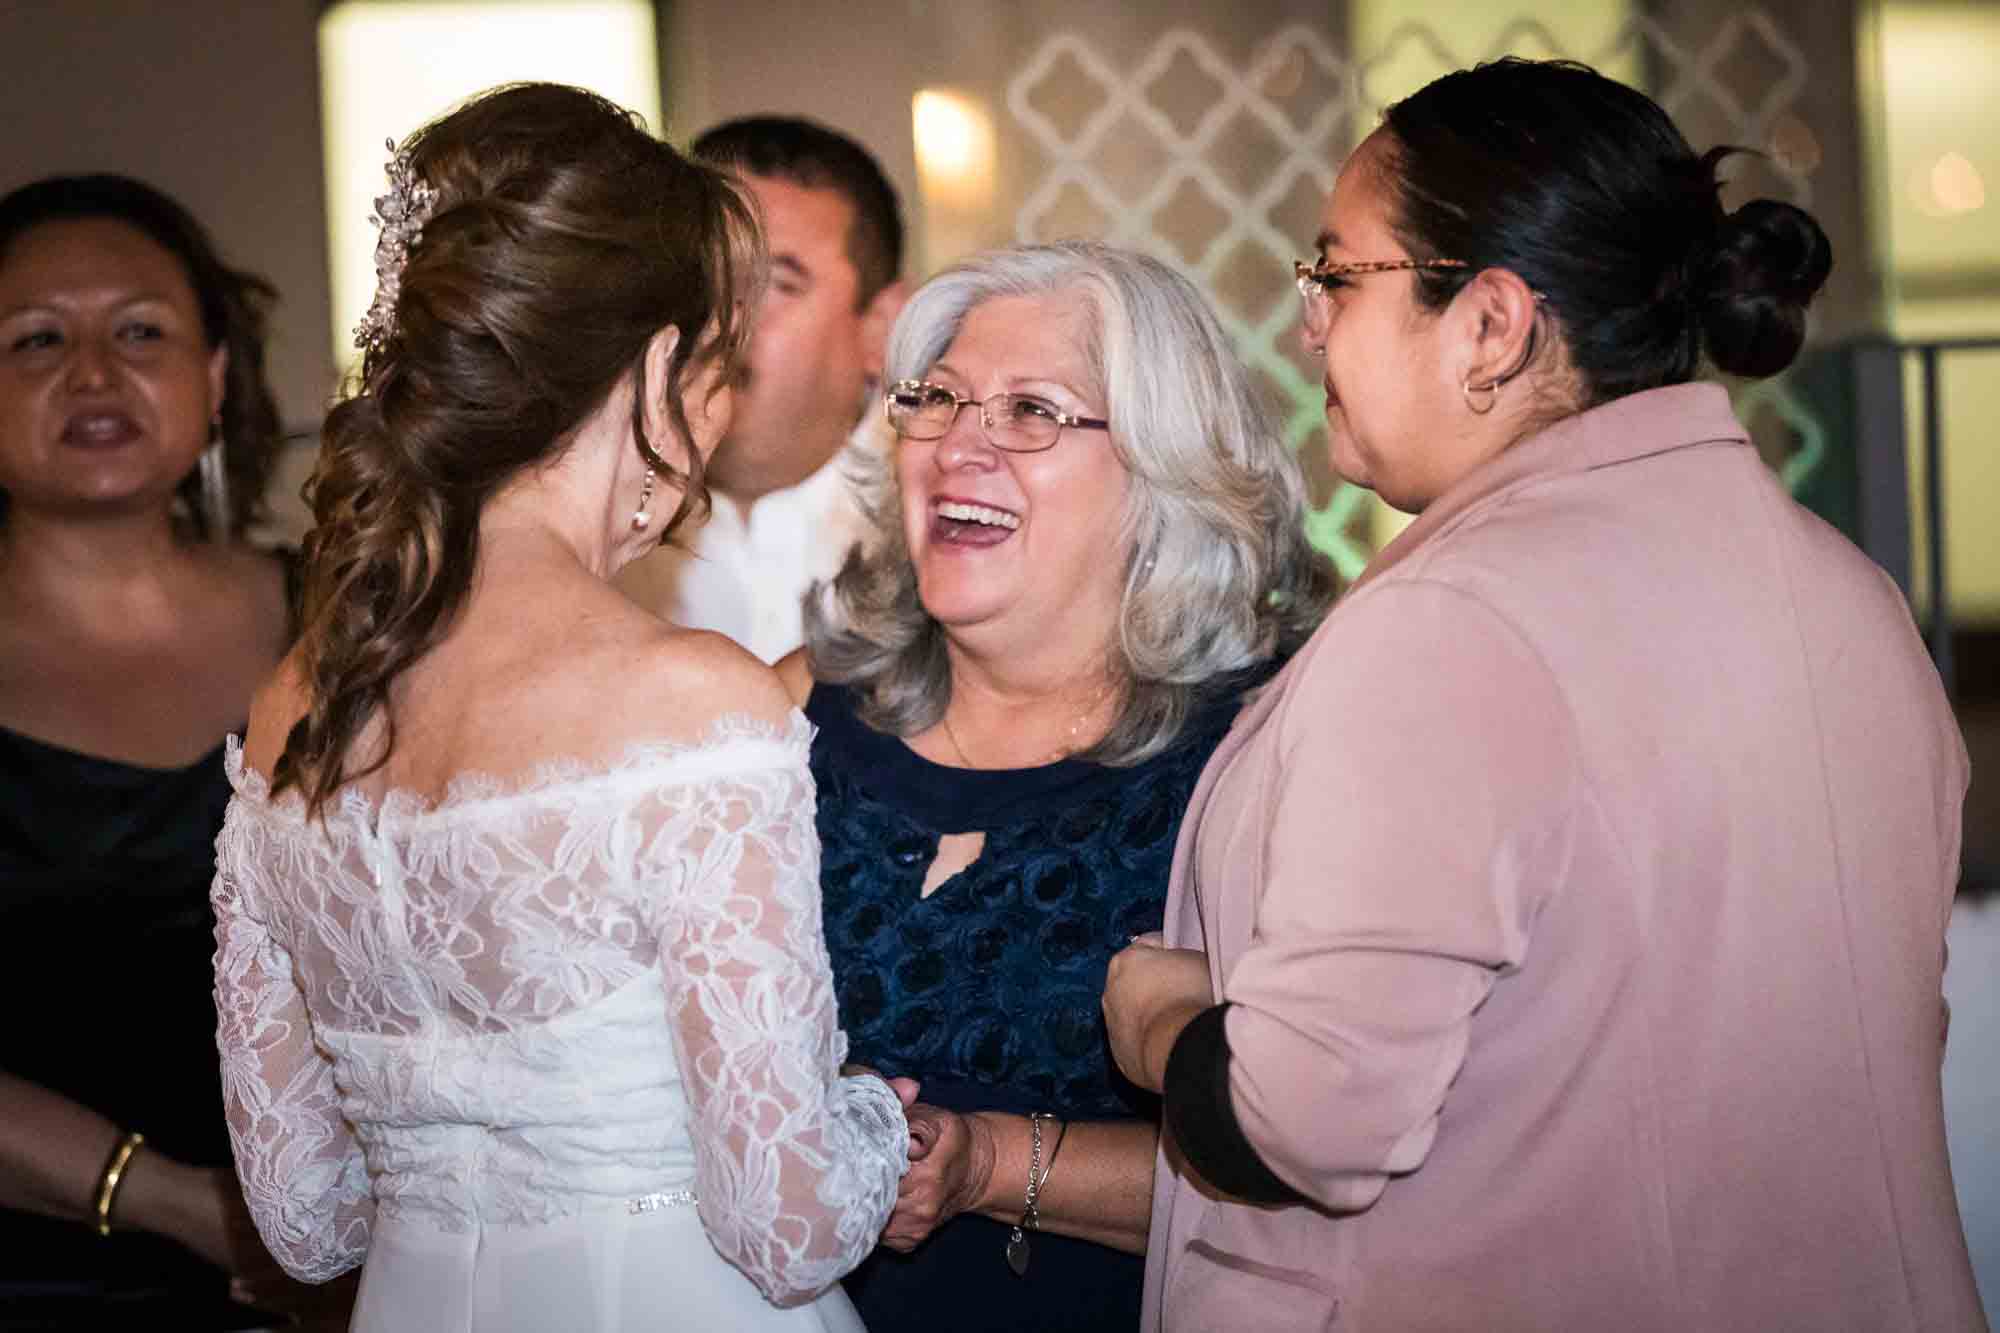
[{"xmin": 210, "ymin": 819, "xmax": 374, "ymax": 1283}]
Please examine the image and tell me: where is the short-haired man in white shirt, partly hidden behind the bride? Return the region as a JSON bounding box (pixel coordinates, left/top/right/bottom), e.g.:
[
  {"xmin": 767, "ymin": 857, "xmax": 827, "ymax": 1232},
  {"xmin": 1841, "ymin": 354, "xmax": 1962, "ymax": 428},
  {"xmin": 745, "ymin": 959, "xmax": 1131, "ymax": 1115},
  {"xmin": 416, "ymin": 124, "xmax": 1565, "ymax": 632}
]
[{"xmin": 618, "ymin": 116, "xmax": 906, "ymax": 662}]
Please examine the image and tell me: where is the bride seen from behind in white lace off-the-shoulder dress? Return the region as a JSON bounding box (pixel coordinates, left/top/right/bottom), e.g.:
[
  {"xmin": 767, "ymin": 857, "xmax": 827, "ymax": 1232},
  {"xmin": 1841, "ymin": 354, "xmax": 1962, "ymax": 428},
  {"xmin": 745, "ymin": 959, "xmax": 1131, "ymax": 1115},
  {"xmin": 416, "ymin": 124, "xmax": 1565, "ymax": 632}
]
[{"xmin": 214, "ymin": 84, "xmax": 914, "ymax": 1329}]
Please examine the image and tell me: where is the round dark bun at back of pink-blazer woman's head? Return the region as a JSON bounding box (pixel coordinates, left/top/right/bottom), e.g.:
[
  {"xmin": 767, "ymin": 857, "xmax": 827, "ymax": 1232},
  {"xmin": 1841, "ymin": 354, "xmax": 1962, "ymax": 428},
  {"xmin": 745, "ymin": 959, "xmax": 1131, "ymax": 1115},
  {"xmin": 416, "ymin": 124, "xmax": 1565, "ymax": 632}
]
[{"xmin": 1696, "ymin": 198, "xmax": 1834, "ymax": 376}]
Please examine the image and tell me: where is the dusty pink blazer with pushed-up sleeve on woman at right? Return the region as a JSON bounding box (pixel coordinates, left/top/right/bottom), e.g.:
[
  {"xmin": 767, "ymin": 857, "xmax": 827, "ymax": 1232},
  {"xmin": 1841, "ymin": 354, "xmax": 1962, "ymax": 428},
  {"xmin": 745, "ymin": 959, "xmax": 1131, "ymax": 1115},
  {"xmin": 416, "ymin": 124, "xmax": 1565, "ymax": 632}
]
[{"xmin": 1144, "ymin": 384, "xmax": 1986, "ymax": 1333}]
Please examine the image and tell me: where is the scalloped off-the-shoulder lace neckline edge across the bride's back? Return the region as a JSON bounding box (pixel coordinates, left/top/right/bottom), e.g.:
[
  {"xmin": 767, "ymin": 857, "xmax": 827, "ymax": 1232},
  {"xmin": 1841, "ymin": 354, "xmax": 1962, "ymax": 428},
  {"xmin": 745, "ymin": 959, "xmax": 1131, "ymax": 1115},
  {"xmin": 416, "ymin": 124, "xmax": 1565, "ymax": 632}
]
[{"xmin": 236, "ymin": 709, "xmax": 814, "ymax": 827}]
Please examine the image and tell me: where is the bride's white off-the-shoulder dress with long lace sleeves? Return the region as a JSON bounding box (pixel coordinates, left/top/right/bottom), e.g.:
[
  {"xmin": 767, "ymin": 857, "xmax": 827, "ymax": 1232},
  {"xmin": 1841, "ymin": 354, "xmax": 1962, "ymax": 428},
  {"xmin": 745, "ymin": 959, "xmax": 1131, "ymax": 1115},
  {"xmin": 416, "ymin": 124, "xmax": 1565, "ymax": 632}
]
[{"xmin": 214, "ymin": 713, "xmax": 908, "ymax": 1333}]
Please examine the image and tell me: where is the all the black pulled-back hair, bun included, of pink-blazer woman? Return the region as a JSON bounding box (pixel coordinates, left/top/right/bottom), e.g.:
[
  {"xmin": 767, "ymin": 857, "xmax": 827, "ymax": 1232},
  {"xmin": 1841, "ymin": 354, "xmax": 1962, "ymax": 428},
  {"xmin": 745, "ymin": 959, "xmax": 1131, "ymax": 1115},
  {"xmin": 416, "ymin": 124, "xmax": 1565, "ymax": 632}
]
[{"xmin": 1384, "ymin": 56, "xmax": 1832, "ymax": 406}]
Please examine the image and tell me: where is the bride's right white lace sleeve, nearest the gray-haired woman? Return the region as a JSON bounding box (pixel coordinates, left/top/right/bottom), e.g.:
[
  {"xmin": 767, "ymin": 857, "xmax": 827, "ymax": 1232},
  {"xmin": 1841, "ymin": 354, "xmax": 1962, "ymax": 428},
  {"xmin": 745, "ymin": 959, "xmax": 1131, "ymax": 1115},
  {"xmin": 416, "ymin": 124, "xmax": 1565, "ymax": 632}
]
[{"xmin": 658, "ymin": 769, "xmax": 910, "ymax": 1305}]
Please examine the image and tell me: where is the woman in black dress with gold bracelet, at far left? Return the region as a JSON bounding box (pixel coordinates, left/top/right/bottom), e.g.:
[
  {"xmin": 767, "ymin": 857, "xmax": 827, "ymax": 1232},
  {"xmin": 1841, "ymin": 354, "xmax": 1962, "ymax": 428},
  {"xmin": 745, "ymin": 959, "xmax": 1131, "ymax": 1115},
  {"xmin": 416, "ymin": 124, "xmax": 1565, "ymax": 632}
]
[{"xmin": 0, "ymin": 176, "xmax": 290, "ymax": 1323}]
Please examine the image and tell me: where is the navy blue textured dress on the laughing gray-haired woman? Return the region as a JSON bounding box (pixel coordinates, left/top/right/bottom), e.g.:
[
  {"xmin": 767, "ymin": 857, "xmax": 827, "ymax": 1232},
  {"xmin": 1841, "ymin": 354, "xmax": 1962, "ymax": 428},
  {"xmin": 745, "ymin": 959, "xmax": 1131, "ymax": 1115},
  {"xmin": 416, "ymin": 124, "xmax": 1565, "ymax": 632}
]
[{"xmin": 806, "ymin": 673, "xmax": 1268, "ymax": 1333}]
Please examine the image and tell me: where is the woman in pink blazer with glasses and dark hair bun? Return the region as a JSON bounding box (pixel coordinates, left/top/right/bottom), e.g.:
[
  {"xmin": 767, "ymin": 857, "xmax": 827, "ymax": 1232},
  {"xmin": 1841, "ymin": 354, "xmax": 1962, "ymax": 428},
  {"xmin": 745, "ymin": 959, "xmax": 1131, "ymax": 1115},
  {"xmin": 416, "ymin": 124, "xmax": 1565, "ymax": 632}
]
[{"xmin": 1104, "ymin": 60, "xmax": 1984, "ymax": 1333}]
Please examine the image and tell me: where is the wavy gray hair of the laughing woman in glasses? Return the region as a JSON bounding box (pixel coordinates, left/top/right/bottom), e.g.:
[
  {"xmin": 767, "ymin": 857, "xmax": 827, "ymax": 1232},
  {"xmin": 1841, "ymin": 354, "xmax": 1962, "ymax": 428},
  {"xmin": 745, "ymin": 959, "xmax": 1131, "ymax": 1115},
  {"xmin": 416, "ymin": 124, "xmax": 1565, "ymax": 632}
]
[{"xmin": 806, "ymin": 242, "xmax": 1336, "ymax": 765}]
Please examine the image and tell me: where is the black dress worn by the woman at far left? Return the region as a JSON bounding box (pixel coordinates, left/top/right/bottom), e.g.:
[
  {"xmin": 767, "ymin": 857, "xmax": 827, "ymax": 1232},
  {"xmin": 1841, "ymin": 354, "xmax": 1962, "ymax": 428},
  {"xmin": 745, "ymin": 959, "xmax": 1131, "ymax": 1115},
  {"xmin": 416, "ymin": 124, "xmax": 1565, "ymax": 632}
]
[{"xmin": 0, "ymin": 729, "xmax": 230, "ymax": 1323}]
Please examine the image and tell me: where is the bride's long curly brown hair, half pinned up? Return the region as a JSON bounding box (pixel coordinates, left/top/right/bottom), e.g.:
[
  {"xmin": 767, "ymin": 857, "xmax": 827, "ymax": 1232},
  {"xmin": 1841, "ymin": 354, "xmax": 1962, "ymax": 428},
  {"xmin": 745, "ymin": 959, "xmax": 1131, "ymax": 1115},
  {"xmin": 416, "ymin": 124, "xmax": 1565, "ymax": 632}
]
[{"xmin": 272, "ymin": 84, "xmax": 762, "ymax": 813}]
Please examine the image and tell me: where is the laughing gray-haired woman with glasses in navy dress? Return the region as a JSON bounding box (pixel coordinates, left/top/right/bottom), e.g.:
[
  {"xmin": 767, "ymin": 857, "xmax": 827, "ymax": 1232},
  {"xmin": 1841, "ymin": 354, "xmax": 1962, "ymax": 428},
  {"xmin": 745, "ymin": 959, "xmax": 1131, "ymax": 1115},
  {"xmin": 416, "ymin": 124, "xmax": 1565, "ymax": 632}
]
[{"xmin": 780, "ymin": 244, "xmax": 1334, "ymax": 1333}]
